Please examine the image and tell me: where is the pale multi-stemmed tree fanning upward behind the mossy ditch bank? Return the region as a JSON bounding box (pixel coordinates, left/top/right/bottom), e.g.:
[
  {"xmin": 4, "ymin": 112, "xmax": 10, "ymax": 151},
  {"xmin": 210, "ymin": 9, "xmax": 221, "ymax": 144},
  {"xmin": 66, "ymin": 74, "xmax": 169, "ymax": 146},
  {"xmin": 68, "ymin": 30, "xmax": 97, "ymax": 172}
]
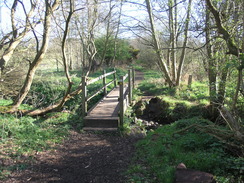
[{"xmin": 146, "ymin": 0, "xmax": 192, "ymax": 86}]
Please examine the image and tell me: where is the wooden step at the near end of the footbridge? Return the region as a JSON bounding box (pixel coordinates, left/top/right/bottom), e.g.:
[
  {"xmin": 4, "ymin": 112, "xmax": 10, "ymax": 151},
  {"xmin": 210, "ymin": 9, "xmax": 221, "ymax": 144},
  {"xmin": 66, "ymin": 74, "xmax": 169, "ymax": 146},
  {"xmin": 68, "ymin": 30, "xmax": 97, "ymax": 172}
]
[{"xmin": 84, "ymin": 116, "xmax": 119, "ymax": 128}]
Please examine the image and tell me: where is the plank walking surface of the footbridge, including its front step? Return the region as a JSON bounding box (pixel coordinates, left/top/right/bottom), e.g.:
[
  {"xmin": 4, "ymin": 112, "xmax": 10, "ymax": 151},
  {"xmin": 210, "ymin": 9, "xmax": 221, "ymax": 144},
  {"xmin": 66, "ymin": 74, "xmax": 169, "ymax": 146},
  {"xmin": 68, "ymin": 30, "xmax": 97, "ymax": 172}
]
[{"xmin": 84, "ymin": 87, "xmax": 119, "ymax": 130}]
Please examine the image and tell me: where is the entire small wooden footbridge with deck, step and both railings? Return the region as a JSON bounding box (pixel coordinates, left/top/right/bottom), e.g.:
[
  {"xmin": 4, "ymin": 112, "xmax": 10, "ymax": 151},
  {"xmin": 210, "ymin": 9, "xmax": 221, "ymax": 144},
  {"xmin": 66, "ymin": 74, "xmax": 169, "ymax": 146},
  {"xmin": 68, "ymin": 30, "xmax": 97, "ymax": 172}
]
[{"xmin": 82, "ymin": 69, "xmax": 135, "ymax": 131}]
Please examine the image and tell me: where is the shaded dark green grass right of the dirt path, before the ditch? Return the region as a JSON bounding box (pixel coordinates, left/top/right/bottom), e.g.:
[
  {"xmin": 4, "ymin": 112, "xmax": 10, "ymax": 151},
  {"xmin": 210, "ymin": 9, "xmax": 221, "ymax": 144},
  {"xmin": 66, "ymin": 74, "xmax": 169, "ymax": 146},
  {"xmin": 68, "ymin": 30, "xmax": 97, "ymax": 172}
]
[{"xmin": 129, "ymin": 118, "xmax": 243, "ymax": 183}]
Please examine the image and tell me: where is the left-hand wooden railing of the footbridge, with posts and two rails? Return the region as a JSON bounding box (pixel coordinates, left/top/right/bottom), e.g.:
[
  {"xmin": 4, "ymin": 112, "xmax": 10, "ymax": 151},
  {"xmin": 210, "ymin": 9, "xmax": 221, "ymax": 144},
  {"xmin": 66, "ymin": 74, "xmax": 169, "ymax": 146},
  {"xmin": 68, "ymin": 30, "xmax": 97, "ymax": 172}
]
[{"xmin": 82, "ymin": 69, "xmax": 117, "ymax": 118}]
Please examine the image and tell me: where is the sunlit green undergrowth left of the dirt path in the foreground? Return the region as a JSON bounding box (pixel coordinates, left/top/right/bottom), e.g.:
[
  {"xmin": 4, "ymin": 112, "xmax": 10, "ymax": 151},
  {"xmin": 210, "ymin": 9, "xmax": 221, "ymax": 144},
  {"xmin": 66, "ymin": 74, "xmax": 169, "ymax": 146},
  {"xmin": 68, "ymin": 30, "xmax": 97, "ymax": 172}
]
[{"xmin": 0, "ymin": 113, "xmax": 78, "ymax": 179}]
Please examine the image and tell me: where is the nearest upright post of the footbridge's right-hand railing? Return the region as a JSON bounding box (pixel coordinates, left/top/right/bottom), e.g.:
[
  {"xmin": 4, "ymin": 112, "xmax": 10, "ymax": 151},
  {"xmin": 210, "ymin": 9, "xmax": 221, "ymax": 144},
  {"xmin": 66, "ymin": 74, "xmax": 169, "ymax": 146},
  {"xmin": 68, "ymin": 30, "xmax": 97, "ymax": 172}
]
[{"xmin": 119, "ymin": 76, "xmax": 124, "ymax": 126}]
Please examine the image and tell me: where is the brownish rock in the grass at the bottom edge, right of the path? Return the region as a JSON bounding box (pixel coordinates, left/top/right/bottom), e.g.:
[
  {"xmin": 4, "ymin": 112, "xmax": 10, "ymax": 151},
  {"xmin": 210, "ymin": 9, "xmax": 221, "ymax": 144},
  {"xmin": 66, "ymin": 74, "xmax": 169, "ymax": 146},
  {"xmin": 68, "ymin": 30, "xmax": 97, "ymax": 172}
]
[{"xmin": 175, "ymin": 163, "xmax": 216, "ymax": 183}]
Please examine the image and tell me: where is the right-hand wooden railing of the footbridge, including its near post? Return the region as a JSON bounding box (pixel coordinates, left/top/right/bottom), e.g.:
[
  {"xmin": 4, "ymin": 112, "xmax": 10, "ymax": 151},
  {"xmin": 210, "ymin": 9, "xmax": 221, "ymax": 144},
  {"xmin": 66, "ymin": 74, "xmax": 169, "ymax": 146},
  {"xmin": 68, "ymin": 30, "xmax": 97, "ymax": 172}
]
[{"xmin": 118, "ymin": 68, "xmax": 135, "ymax": 126}]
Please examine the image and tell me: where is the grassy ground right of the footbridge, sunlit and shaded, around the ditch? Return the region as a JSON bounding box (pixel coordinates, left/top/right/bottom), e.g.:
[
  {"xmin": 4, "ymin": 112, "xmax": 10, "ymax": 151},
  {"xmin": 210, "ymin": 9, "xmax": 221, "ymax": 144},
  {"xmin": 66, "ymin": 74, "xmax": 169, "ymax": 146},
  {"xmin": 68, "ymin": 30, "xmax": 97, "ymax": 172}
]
[{"xmin": 127, "ymin": 67, "xmax": 244, "ymax": 183}]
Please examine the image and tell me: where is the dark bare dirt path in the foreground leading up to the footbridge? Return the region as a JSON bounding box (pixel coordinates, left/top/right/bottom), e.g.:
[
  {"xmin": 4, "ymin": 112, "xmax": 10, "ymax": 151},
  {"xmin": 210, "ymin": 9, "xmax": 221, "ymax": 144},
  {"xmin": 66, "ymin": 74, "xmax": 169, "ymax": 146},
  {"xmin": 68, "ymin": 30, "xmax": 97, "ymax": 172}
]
[{"xmin": 2, "ymin": 131, "xmax": 141, "ymax": 183}]
